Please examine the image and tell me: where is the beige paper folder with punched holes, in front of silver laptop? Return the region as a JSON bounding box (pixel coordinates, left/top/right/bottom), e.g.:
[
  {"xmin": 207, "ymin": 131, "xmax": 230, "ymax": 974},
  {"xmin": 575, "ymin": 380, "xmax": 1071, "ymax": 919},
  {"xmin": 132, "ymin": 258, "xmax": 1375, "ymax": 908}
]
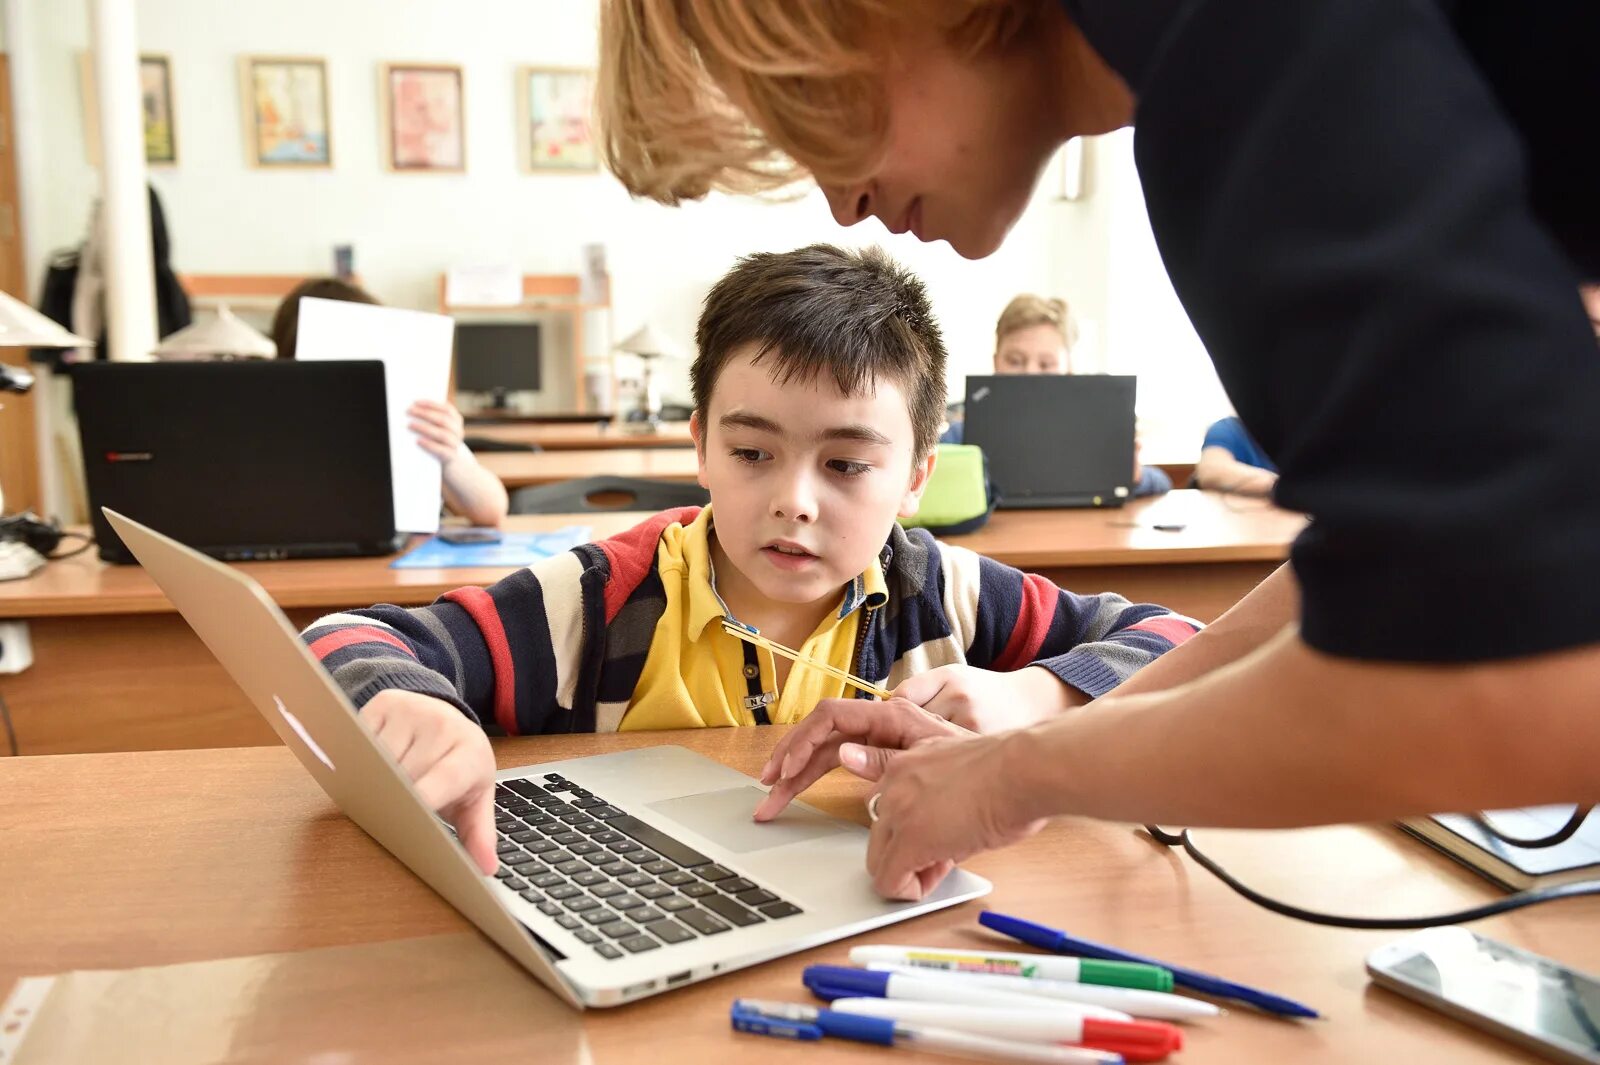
[{"xmin": 0, "ymin": 934, "xmax": 589, "ymax": 1065}]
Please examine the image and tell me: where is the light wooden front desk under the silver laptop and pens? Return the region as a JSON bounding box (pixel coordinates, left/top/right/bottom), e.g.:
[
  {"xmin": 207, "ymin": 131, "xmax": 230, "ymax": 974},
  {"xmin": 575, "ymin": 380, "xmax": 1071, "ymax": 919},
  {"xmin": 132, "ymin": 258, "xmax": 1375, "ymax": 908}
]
[{"xmin": 0, "ymin": 729, "xmax": 1600, "ymax": 1065}]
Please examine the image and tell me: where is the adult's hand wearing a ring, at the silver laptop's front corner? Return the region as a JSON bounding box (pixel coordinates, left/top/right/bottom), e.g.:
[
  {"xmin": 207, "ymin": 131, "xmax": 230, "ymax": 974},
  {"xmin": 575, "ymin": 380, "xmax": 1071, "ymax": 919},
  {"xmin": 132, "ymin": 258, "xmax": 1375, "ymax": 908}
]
[{"xmin": 867, "ymin": 732, "xmax": 1045, "ymax": 899}]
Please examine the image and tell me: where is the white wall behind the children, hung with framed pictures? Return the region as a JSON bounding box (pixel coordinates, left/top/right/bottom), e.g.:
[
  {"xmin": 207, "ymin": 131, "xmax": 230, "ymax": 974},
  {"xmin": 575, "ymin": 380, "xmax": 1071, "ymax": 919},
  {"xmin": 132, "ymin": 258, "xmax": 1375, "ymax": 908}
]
[{"xmin": 6, "ymin": 0, "xmax": 1216, "ymax": 457}]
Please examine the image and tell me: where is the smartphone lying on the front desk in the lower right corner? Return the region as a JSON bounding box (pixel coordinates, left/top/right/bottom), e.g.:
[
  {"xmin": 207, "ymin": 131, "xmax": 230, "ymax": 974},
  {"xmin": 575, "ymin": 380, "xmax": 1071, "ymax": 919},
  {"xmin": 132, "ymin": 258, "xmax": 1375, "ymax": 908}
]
[{"xmin": 1366, "ymin": 927, "xmax": 1600, "ymax": 1065}]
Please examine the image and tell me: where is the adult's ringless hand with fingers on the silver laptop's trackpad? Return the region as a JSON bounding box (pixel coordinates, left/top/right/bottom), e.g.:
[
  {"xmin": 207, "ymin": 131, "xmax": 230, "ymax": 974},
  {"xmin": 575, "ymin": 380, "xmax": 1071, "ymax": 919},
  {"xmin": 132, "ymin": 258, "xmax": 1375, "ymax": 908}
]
[{"xmin": 755, "ymin": 699, "xmax": 971, "ymax": 820}]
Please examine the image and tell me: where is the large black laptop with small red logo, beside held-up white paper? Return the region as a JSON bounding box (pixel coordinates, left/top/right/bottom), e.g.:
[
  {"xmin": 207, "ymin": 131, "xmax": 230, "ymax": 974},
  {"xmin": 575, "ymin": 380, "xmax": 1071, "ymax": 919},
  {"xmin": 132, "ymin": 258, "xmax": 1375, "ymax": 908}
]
[{"xmin": 72, "ymin": 360, "xmax": 400, "ymax": 563}]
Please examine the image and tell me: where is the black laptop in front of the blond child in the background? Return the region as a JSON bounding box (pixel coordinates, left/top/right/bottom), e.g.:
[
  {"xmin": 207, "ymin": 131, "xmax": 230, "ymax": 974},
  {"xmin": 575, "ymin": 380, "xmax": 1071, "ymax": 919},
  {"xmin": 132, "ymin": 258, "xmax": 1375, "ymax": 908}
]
[{"xmin": 962, "ymin": 374, "xmax": 1136, "ymax": 507}]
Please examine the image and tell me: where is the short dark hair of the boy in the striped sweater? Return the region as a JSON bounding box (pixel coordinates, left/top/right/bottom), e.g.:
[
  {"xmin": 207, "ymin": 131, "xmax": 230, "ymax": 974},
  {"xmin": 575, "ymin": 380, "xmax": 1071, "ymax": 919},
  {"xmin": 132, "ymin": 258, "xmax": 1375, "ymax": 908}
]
[{"xmin": 690, "ymin": 245, "xmax": 946, "ymax": 457}]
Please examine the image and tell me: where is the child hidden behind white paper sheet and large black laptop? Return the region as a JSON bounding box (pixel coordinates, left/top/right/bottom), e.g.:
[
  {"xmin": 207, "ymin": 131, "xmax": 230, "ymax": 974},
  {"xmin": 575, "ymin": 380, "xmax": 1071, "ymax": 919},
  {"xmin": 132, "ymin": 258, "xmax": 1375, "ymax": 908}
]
[{"xmin": 272, "ymin": 277, "xmax": 510, "ymax": 526}]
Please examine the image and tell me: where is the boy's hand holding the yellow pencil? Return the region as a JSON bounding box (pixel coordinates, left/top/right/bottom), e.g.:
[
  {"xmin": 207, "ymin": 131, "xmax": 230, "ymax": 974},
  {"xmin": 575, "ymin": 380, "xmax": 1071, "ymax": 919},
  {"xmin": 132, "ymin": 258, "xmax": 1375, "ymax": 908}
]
[{"xmin": 894, "ymin": 665, "xmax": 1090, "ymax": 734}]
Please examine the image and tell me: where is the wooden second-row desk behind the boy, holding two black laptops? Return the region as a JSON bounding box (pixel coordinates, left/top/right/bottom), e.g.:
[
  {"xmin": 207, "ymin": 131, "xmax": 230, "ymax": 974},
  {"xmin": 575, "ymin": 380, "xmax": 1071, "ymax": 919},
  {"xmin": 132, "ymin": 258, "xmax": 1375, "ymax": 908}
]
[{"xmin": 0, "ymin": 492, "xmax": 1304, "ymax": 755}]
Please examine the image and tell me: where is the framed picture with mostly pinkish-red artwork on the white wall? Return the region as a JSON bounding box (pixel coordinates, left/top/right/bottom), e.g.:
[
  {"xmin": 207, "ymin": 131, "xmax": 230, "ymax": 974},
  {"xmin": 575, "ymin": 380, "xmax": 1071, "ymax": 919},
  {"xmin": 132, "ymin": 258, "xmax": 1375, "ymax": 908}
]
[{"xmin": 381, "ymin": 62, "xmax": 467, "ymax": 173}]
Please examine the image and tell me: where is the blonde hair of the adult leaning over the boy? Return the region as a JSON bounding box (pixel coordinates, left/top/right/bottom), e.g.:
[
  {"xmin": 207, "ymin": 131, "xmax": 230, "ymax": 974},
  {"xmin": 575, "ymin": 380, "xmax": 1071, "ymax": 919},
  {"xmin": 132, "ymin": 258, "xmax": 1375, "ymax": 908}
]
[{"xmin": 595, "ymin": 0, "xmax": 1059, "ymax": 205}]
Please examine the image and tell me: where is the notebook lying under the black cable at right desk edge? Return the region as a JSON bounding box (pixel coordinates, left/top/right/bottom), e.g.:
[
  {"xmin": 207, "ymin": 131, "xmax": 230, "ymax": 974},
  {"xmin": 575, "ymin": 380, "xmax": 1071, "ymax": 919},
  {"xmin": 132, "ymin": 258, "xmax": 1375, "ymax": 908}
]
[{"xmin": 1400, "ymin": 806, "xmax": 1600, "ymax": 891}]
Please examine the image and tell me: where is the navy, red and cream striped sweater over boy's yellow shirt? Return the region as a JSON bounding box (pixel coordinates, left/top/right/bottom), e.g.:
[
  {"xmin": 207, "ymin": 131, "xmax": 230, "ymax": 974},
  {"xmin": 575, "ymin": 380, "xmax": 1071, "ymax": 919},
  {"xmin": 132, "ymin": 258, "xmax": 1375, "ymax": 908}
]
[{"xmin": 304, "ymin": 507, "xmax": 1198, "ymax": 734}]
